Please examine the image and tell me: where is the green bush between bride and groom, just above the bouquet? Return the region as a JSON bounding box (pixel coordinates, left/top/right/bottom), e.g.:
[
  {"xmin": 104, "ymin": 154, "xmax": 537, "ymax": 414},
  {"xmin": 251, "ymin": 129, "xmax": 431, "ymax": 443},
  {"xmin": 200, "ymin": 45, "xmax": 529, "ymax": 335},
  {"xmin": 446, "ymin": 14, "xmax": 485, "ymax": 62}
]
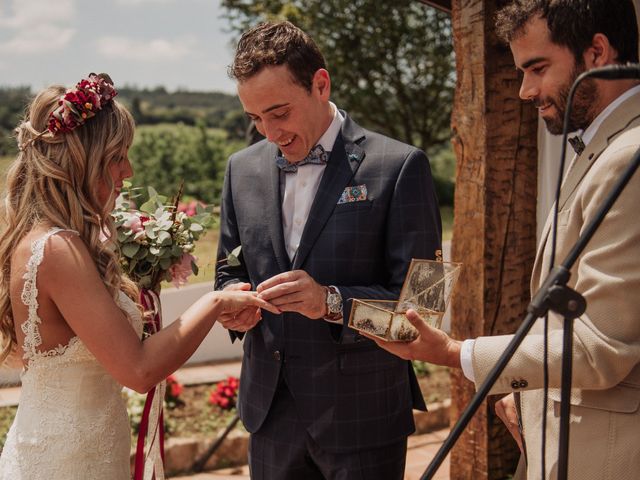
[{"xmin": 129, "ymin": 124, "xmax": 244, "ymax": 203}]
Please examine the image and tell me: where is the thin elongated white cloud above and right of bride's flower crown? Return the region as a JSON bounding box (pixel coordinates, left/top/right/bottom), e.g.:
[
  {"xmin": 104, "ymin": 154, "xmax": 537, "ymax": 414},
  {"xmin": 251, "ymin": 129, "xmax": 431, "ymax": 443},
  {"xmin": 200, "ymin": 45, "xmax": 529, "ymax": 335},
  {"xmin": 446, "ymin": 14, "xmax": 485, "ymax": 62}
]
[{"xmin": 97, "ymin": 36, "xmax": 197, "ymax": 62}]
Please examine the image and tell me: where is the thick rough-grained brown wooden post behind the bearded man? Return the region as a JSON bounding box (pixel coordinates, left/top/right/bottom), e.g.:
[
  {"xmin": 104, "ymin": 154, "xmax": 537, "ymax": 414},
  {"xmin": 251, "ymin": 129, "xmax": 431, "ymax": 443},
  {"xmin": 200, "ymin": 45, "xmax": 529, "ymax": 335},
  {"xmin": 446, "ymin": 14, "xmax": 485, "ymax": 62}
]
[{"xmin": 451, "ymin": 0, "xmax": 537, "ymax": 480}]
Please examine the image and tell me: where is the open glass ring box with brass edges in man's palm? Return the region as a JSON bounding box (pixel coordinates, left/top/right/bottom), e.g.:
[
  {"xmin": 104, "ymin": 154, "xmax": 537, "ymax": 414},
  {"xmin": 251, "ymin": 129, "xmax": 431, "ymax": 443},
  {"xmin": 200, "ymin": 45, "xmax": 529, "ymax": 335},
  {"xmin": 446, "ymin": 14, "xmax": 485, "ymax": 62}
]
[{"xmin": 349, "ymin": 258, "xmax": 462, "ymax": 342}]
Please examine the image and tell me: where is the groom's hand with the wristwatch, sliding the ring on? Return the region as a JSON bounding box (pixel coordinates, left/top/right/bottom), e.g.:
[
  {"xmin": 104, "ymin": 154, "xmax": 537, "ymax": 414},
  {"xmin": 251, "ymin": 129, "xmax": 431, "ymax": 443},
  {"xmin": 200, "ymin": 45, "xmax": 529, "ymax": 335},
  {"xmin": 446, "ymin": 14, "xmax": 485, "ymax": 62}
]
[{"xmin": 256, "ymin": 270, "xmax": 327, "ymax": 318}]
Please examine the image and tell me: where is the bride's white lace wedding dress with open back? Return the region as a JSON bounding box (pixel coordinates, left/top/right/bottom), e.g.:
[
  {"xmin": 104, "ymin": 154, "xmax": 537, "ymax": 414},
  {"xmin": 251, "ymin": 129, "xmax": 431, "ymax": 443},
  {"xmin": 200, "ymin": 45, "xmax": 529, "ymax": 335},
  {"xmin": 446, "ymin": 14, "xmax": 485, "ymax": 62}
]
[{"xmin": 0, "ymin": 229, "xmax": 142, "ymax": 480}]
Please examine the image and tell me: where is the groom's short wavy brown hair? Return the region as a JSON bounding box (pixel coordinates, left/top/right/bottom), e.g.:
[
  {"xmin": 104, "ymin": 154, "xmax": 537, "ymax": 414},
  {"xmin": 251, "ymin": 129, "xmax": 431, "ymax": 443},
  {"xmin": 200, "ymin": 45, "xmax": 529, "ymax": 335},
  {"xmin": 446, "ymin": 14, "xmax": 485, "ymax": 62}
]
[{"xmin": 229, "ymin": 22, "xmax": 327, "ymax": 91}]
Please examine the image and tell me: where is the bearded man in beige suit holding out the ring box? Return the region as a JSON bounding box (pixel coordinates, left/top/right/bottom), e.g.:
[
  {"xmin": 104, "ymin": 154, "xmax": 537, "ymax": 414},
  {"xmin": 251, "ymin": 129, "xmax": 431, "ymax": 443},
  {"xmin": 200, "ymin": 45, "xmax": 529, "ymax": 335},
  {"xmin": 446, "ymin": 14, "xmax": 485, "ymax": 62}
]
[{"xmin": 368, "ymin": 0, "xmax": 640, "ymax": 480}]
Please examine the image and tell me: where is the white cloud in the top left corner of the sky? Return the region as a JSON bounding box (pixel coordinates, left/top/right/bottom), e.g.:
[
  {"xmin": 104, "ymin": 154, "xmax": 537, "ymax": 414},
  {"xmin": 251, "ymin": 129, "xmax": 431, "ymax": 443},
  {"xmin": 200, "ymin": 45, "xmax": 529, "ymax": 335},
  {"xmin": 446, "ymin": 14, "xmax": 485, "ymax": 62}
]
[{"xmin": 0, "ymin": 0, "xmax": 76, "ymax": 55}]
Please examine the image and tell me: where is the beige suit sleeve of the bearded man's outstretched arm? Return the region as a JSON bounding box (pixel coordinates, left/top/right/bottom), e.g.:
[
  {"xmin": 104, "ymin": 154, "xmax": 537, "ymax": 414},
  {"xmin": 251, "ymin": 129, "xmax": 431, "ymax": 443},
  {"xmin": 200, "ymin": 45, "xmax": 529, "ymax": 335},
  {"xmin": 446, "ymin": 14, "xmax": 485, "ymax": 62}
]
[{"xmin": 473, "ymin": 140, "xmax": 640, "ymax": 394}]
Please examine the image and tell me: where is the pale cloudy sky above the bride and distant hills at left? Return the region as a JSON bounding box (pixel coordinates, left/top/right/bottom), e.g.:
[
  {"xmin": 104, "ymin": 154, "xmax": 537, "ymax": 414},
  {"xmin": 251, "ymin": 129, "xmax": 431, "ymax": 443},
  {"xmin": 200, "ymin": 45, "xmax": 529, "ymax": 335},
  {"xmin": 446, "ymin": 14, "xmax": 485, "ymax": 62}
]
[{"xmin": 0, "ymin": 0, "xmax": 240, "ymax": 93}]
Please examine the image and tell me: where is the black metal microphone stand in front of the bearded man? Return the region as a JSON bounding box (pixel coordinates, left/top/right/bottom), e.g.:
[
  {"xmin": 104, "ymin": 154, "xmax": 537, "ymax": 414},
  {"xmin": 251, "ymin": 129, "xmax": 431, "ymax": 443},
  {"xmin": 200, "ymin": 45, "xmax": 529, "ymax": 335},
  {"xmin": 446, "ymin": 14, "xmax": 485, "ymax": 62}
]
[{"xmin": 420, "ymin": 65, "xmax": 640, "ymax": 480}]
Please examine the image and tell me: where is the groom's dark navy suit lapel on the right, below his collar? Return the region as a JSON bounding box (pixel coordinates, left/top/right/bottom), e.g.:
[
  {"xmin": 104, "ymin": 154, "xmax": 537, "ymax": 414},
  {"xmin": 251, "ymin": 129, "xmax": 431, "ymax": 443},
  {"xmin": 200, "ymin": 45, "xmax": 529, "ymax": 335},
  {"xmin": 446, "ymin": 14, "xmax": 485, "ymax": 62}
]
[{"xmin": 293, "ymin": 112, "xmax": 365, "ymax": 270}]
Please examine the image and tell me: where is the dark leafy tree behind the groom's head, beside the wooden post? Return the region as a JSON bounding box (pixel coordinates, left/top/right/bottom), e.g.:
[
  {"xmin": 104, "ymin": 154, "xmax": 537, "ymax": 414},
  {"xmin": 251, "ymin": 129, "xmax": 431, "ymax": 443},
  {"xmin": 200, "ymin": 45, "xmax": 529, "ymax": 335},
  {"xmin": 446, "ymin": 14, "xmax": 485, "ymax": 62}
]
[{"xmin": 222, "ymin": 0, "xmax": 455, "ymax": 150}]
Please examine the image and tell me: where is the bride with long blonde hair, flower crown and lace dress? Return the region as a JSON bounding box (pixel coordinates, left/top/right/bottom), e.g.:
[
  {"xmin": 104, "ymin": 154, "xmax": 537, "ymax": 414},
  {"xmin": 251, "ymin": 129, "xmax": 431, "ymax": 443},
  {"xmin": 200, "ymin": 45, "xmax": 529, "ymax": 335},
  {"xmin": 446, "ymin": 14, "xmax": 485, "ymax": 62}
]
[{"xmin": 0, "ymin": 74, "xmax": 277, "ymax": 480}]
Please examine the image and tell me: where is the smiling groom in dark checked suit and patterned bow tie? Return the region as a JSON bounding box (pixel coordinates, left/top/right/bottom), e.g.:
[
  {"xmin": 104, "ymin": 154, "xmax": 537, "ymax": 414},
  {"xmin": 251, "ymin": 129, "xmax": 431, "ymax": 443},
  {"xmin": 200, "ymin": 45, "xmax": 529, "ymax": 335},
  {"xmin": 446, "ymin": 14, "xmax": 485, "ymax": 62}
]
[{"xmin": 216, "ymin": 22, "xmax": 441, "ymax": 480}]
